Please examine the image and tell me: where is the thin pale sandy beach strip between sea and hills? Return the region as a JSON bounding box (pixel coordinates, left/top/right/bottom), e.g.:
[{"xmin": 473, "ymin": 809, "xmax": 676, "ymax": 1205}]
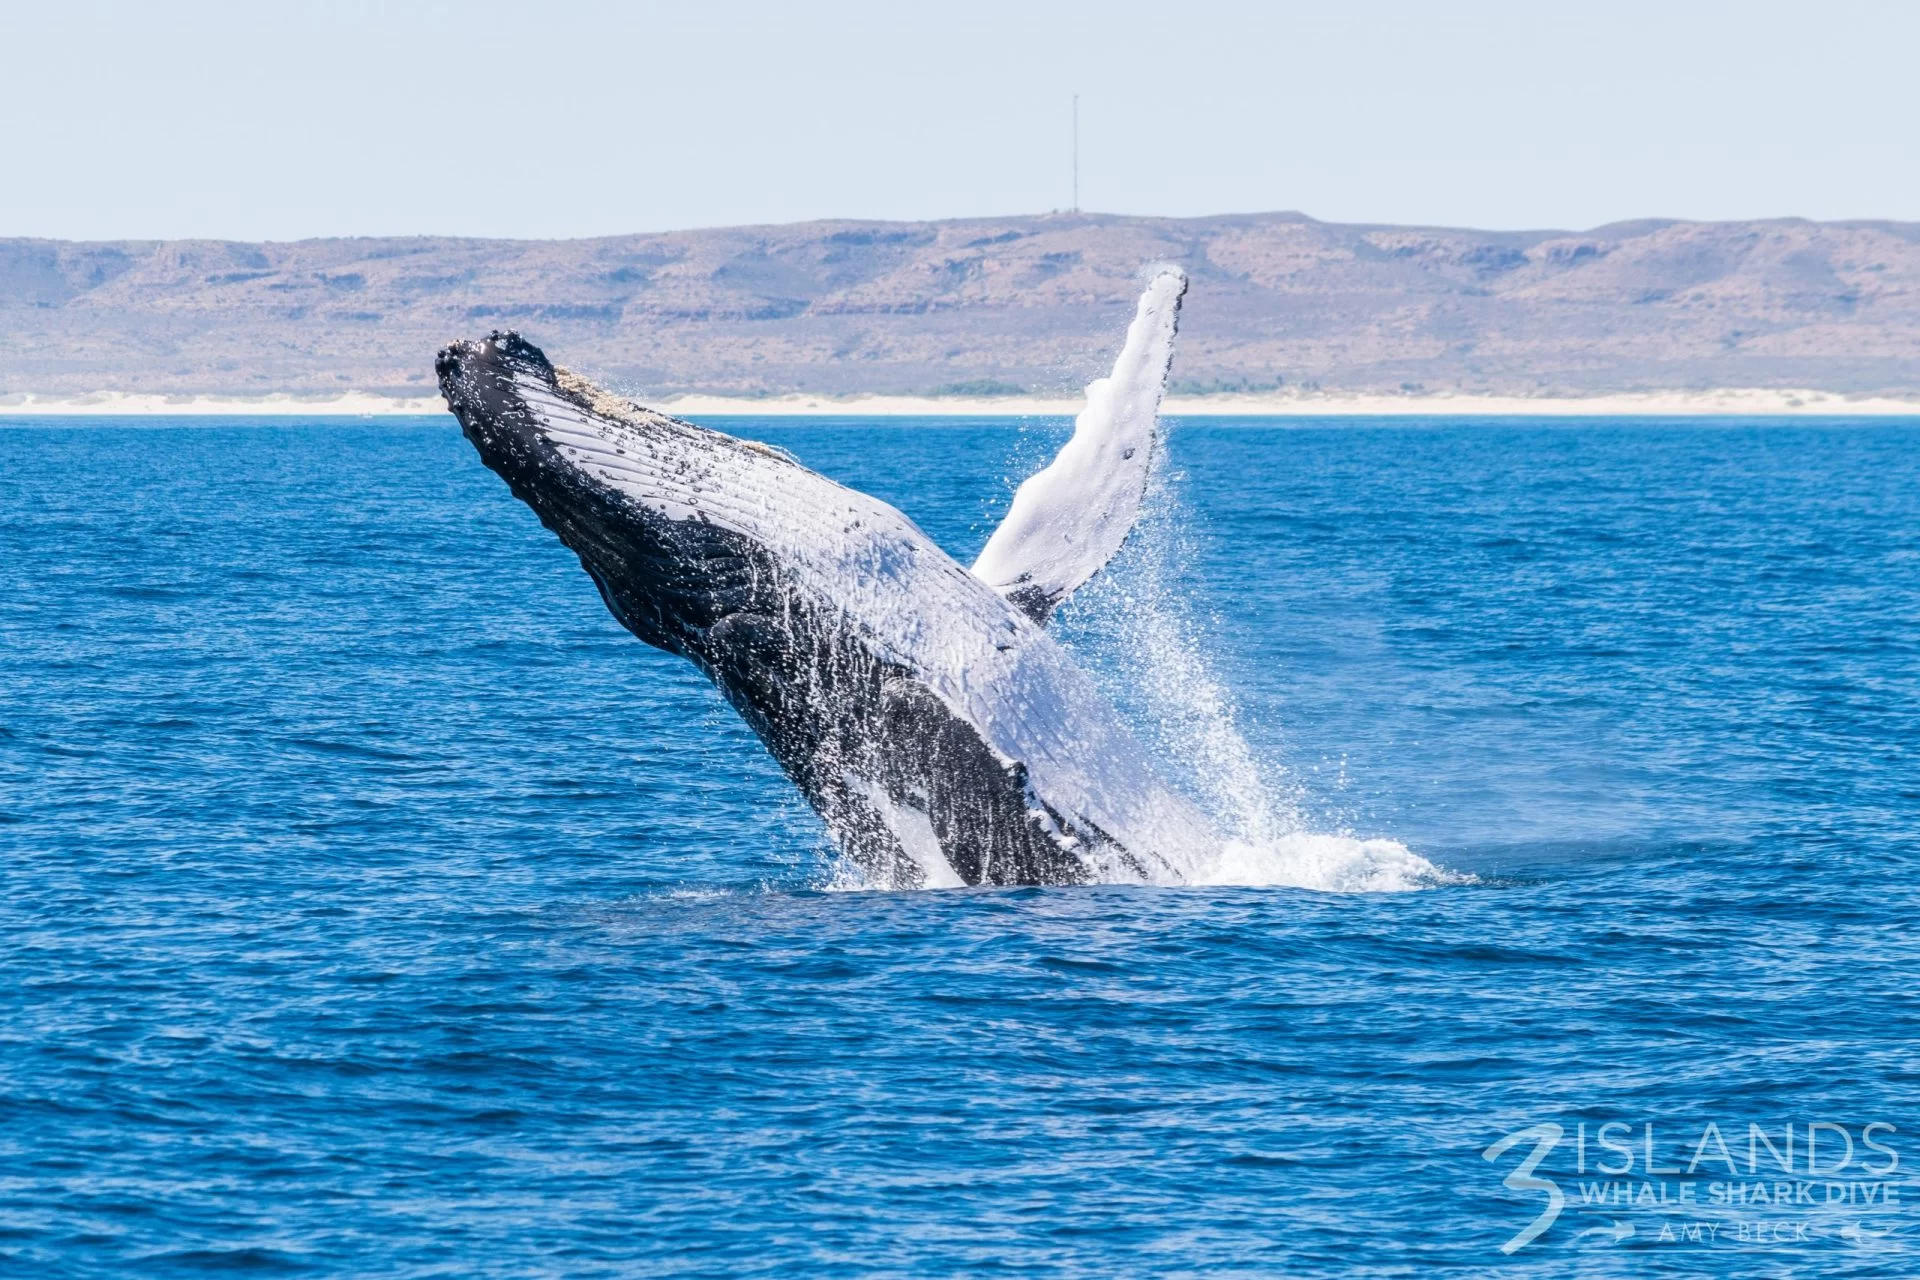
[{"xmin": 0, "ymin": 388, "xmax": 1920, "ymax": 418}]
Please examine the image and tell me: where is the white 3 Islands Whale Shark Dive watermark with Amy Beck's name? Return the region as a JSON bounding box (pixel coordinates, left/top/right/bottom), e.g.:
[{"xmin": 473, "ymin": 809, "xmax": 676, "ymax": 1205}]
[{"xmin": 1480, "ymin": 1121, "xmax": 1905, "ymax": 1255}]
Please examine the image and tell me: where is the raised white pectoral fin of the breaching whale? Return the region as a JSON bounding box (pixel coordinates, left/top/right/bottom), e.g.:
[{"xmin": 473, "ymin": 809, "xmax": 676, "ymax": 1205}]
[{"xmin": 973, "ymin": 267, "xmax": 1187, "ymax": 622}]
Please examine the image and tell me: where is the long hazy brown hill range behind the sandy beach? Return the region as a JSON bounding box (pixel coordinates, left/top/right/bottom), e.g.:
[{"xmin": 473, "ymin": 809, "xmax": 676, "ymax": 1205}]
[{"xmin": 0, "ymin": 213, "xmax": 1920, "ymax": 395}]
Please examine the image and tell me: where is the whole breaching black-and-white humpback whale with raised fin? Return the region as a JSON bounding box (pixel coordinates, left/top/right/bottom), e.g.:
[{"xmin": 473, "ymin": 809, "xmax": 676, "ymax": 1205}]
[{"xmin": 436, "ymin": 269, "xmax": 1221, "ymax": 889}]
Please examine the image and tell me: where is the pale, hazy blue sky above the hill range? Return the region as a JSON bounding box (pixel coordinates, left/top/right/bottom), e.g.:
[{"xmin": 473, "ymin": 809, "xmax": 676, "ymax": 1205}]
[{"xmin": 0, "ymin": 0, "xmax": 1920, "ymax": 240}]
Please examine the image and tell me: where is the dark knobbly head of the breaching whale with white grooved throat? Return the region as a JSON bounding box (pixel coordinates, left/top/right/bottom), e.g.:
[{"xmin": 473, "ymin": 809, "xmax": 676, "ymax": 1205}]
[{"xmin": 434, "ymin": 332, "xmax": 804, "ymax": 660}]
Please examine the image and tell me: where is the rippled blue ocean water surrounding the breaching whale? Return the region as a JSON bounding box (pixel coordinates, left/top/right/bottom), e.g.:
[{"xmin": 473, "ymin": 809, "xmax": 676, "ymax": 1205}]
[{"xmin": 0, "ymin": 418, "xmax": 1920, "ymax": 1278}]
